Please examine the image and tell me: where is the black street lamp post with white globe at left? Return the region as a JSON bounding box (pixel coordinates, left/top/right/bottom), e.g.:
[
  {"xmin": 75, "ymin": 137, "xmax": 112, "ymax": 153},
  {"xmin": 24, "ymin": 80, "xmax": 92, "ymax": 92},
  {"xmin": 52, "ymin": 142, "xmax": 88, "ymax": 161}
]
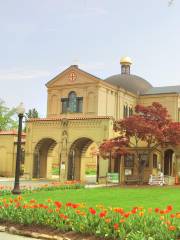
[{"xmin": 12, "ymin": 103, "xmax": 25, "ymax": 194}]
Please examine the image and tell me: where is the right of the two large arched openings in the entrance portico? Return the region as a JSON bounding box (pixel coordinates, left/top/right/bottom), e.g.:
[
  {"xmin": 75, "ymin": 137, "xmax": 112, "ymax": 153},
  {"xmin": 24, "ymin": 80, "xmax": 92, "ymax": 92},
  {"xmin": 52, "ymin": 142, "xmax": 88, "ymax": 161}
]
[{"xmin": 67, "ymin": 137, "xmax": 97, "ymax": 181}]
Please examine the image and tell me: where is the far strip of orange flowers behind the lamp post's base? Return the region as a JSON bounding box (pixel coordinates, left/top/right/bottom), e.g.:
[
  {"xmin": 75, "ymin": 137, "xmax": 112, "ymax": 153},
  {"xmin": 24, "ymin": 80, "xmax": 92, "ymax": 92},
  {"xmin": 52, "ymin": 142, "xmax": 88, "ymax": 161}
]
[{"xmin": 0, "ymin": 181, "xmax": 84, "ymax": 196}]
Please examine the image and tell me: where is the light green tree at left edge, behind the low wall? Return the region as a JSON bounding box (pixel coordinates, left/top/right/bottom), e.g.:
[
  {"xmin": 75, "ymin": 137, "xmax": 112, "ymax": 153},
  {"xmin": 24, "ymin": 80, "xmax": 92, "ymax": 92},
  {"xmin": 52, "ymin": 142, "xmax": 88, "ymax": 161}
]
[{"xmin": 0, "ymin": 99, "xmax": 18, "ymax": 131}]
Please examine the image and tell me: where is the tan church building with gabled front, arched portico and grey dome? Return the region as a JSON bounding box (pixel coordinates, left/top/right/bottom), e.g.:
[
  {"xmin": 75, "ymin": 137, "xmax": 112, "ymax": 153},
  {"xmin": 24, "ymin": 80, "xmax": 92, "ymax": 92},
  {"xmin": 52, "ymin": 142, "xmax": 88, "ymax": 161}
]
[{"xmin": 0, "ymin": 57, "xmax": 180, "ymax": 182}]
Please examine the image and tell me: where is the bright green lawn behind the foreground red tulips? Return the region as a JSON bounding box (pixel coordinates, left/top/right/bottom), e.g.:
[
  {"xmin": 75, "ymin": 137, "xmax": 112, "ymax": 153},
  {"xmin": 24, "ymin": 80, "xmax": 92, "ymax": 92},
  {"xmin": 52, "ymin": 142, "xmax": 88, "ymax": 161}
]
[{"xmin": 16, "ymin": 187, "xmax": 180, "ymax": 212}]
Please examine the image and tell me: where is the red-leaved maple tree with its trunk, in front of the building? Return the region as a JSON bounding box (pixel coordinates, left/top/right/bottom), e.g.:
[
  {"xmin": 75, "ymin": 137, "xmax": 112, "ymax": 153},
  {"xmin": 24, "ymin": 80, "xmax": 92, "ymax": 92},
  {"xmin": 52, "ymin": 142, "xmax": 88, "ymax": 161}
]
[{"xmin": 100, "ymin": 102, "xmax": 180, "ymax": 182}]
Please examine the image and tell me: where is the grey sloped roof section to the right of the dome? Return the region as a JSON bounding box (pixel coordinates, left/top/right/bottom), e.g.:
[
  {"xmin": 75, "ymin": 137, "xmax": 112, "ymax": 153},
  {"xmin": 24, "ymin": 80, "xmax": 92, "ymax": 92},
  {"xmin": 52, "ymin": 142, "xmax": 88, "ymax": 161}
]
[{"xmin": 142, "ymin": 85, "xmax": 180, "ymax": 95}]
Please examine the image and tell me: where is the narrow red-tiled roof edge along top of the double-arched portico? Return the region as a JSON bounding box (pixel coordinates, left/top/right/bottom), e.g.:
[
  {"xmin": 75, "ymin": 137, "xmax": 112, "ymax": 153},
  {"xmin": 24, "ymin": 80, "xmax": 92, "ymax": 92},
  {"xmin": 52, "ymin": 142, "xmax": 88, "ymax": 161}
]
[{"xmin": 28, "ymin": 116, "xmax": 113, "ymax": 122}]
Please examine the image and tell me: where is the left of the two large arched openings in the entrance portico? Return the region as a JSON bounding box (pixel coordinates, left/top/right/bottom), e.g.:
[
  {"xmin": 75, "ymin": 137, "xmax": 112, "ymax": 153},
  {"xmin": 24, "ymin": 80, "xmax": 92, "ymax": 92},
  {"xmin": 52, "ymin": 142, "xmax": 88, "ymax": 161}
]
[{"xmin": 33, "ymin": 138, "xmax": 57, "ymax": 178}]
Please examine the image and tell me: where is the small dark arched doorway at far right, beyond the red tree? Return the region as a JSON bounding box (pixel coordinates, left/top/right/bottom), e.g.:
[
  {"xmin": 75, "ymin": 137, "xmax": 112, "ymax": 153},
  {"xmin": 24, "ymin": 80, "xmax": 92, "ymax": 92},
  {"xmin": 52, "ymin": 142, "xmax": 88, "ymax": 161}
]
[{"xmin": 164, "ymin": 149, "xmax": 174, "ymax": 176}]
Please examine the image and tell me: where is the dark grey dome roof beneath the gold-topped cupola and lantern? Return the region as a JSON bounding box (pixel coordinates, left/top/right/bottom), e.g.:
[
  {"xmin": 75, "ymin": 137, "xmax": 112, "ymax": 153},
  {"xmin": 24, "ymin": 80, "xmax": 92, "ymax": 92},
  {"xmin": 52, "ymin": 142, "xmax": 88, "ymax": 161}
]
[{"xmin": 104, "ymin": 74, "xmax": 152, "ymax": 95}]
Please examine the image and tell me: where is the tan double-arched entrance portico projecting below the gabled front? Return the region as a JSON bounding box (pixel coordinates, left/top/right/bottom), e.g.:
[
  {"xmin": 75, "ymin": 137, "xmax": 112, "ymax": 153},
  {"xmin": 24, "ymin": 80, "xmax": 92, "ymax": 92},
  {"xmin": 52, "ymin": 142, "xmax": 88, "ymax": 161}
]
[{"xmin": 25, "ymin": 116, "xmax": 113, "ymax": 181}]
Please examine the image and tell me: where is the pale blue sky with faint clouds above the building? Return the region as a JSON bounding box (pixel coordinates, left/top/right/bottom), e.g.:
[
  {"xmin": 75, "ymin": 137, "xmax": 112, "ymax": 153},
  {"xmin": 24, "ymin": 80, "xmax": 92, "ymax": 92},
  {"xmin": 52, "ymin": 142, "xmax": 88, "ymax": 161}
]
[{"xmin": 0, "ymin": 0, "xmax": 180, "ymax": 117}]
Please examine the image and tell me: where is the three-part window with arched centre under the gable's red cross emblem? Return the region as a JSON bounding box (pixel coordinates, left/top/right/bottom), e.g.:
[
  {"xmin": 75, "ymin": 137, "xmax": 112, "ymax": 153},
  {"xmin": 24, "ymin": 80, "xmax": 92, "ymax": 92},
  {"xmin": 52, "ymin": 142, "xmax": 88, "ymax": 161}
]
[{"xmin": 61, "ymin": 92, "xmax": 83, "ymax": 113}]
